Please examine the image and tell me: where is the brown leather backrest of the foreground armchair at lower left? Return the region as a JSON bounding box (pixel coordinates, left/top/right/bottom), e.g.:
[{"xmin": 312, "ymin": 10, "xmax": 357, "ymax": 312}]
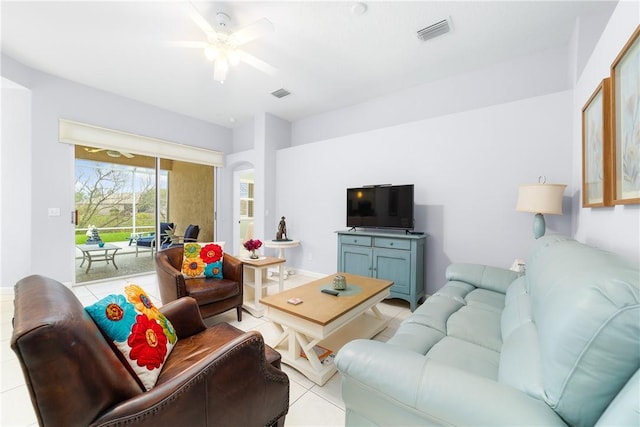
[{"xmin": 11, "ymin": 276, "xmax": 143, "ymax": 426}]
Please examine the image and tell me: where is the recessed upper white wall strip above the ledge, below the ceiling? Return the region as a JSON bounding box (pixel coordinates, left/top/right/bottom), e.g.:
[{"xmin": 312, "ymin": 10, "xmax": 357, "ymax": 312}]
[{"xmin": 292, "ymin": 47, "xmax": 570, "ymax": 145}]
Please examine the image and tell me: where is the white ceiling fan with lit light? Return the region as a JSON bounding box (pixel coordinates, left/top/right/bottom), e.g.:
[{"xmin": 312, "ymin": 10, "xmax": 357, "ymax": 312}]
[{"xmin": 173, "ymin": 5, "xmax": 277, "ymax": 83}]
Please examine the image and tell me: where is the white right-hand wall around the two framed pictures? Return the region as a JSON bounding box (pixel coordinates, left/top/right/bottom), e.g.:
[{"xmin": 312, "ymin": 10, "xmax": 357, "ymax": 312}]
[{"xmin": 571, "ymin": 1, "xmax": 640, "ymax": 262}]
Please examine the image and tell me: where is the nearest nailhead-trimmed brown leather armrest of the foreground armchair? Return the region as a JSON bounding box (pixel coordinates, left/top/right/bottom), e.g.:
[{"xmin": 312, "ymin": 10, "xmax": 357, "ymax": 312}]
[{"xmin": 91, "ymin": 332, "xmax": 289, "ymax": 427}]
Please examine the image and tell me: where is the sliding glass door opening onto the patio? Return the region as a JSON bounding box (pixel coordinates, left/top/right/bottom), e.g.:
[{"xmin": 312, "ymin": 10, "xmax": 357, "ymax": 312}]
[{"xmin": 74, "ymin": 145, "xmax": 214, "ymax": 283}]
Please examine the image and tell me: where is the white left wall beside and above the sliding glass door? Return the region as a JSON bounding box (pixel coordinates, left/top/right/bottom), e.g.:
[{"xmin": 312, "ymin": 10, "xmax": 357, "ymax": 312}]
[{"xmin": 2, "ymin": 55, "xmax": 232, "ymax": 286}]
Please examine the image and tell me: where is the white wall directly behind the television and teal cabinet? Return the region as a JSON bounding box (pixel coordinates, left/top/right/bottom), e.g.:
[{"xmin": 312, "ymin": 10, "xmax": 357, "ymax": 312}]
[{"xmin": 276, "ymin": 91, "xmax": 573, "ymax": 293}]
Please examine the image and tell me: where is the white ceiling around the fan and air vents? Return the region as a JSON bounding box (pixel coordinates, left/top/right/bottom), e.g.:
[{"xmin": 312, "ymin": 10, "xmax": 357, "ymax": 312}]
[{"xmin": 1, "ymin": 0, "xmax": 616, "ymax": 127}]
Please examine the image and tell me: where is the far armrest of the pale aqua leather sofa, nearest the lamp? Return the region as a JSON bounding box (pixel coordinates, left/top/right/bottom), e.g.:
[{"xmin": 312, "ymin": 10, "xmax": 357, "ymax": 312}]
[{"xmin": 445, "ymin": 263, "xmax": 520, "ymax": 294}]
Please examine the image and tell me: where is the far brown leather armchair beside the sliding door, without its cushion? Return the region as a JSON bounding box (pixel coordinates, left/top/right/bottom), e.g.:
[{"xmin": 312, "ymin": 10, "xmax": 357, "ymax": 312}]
[{"xmin": 155, "ymin": 246, "xmax": 242, "ymax": 321}]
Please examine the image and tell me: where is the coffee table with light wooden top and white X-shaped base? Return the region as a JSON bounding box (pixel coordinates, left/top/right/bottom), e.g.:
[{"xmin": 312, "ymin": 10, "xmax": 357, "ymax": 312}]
[{"xmin": 261, "ymin": 273, "xmax": 393, "ymax": 385}]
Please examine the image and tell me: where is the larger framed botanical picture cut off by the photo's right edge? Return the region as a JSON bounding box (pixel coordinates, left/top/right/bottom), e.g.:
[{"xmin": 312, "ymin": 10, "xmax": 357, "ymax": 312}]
[{"xmin": 611, "ymin": 25, "xmax": 640, "ymax": 204}]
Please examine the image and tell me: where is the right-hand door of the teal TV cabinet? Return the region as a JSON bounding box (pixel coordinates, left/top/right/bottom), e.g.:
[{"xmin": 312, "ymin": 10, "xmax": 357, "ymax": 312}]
[{"xmin": 373, "ymin": 248, "xmax": 411, "ymax": 295}]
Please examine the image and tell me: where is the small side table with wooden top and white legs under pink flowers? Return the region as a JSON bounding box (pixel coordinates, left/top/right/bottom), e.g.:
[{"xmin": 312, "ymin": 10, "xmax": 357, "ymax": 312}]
[{"xmin": 240, "ymin": 257, "xmax": 286, "ymax": 317}]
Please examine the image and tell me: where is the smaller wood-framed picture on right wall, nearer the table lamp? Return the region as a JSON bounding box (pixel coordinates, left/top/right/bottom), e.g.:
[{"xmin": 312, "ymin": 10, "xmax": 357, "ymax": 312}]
[{"xmin": 582, "ymin": 78, "xmax": 613, "ymax": 207}]
